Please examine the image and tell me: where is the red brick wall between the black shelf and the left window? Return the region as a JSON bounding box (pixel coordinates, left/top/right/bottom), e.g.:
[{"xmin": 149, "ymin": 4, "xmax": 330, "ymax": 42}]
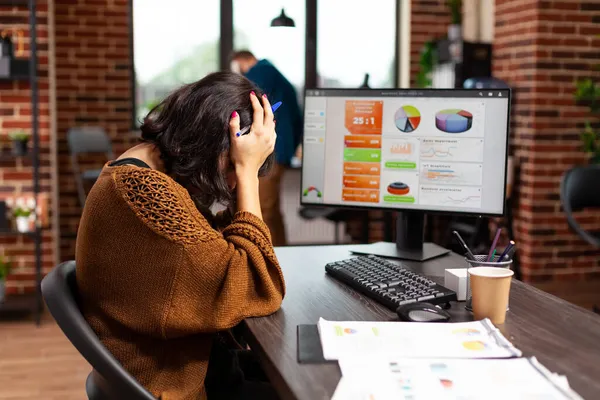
[{"xmin": 55, "ymin": 0, "xmax": 133, "ymax": 260}]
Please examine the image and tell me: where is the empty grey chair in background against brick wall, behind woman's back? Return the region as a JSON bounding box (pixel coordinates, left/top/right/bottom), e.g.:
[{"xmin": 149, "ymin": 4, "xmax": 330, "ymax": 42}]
[{"xmin": 67, "ymin": 127, "xmax": 114, "ymax": 207}]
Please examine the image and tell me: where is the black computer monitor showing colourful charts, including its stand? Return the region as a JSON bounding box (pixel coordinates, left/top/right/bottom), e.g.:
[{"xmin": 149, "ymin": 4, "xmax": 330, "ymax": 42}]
[{"xmin": 300, "ymin": 89, "xmax": 510, "ymax": 260}]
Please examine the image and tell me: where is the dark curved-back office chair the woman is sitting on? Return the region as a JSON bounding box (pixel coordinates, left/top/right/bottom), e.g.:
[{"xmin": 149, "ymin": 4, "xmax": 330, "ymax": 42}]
[{"xmin": 42, "ymin": 261, "xmax": 156, "ymax": 400}]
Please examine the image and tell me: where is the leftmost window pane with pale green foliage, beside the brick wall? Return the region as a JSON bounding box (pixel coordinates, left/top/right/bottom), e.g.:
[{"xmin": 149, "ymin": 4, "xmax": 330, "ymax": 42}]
[{"xmin": 133, "ymin": 0, "xmax": 220, "ymax": 121}]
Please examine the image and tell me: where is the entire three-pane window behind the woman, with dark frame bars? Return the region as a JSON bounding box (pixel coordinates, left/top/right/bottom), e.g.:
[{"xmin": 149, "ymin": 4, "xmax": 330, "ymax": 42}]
[{"xmin": 130, "ymin": 0, "xmax": 400, "ymax": 125}]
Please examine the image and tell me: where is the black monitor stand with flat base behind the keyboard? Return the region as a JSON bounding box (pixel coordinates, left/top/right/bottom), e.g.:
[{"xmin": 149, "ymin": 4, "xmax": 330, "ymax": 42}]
[{"xmin": 352, "ymin": 212, "xmax": 450, "ymax": 261}]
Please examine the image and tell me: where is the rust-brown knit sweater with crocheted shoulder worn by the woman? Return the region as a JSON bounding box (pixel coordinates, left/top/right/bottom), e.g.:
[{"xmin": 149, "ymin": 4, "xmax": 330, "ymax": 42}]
[{"xmin": 76, "ymin": 165, "xmax": 285, "ymax": 400}]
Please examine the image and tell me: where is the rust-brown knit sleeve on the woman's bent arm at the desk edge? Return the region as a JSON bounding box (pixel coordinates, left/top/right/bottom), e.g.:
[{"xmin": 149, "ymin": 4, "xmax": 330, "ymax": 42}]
[{"xmin": 165, "ymin": 212, "xmax": 285, "ymax": 337}]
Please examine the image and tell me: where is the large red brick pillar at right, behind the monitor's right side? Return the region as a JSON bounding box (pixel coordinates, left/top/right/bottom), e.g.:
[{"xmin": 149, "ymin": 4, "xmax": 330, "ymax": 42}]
[{"xmin": 493, "ymin": 0, "xmax": 600, "ymax": 282}]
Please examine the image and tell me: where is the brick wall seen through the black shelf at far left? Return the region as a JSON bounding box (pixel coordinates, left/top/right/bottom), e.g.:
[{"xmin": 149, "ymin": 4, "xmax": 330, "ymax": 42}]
[{"xmin": 0, "ymin": 0, "xmax": 55, "ymax": 294}]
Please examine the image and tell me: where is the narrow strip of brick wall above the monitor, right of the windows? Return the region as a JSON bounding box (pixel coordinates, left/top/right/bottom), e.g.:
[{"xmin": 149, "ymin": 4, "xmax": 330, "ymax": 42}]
[{"xmin": 410, "ymin": 0, "xmax": 450, "ymax": 85}]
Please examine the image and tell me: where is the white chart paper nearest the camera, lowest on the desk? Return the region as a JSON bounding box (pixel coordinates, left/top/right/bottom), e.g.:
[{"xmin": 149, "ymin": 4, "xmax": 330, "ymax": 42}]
[{"xmin": 334, "ymin": 358, "xmax": 582, "ymax": 400}]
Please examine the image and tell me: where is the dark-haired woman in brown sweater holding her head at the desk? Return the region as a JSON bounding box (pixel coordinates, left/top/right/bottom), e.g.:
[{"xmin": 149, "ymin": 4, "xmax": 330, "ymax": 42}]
[{"xmin": 76, "ymin": 73, "xmax": 285, "ymax": 400}]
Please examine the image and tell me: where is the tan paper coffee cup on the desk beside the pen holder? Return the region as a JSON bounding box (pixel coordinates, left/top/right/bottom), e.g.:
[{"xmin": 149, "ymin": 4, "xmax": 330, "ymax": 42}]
[{"xmin": 469, "ymin": 267, "xmax": 514, "ymax": 325}]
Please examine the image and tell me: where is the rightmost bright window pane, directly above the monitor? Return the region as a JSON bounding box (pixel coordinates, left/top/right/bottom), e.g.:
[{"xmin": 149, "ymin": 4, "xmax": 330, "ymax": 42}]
[{"xmin": 317, "ymin": 0, "xmax": 398, "ymax": 88}]
